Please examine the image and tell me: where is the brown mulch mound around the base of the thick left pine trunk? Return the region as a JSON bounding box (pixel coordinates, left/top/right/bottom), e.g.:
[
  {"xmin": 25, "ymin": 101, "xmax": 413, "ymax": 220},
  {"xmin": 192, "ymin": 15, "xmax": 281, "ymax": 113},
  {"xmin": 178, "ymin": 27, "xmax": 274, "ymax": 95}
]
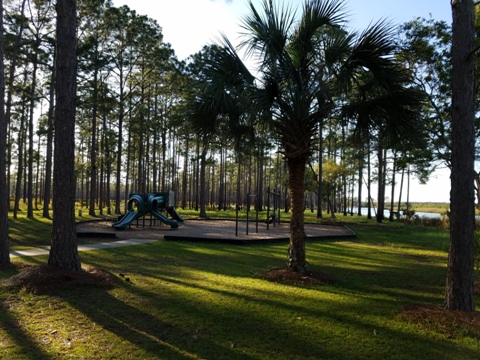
[{"xmin": 0, "ymin": 263, "xmax": 116, "ymax": 293}]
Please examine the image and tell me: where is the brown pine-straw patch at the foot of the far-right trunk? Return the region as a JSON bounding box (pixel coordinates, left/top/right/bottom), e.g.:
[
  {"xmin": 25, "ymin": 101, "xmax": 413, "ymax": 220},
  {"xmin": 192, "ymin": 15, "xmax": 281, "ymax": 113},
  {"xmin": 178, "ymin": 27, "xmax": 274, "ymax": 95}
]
[{"xmin": 398, "ymin": 305, "xmax": 480, "ymax": 338}]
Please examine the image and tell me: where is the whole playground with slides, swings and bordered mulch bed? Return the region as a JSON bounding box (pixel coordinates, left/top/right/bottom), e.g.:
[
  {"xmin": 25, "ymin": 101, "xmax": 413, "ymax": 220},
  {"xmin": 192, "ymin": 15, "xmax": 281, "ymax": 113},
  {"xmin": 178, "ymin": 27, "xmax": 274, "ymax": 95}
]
[{"xmin": 85, "ymin": 189, "xmax": 355, "ymax": 243}]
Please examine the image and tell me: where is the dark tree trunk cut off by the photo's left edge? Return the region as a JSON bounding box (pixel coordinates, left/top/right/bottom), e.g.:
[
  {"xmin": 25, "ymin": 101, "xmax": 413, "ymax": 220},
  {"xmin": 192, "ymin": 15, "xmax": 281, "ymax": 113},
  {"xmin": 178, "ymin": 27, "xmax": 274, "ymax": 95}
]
[{"xmin": 0, "ymin": 0, "xmax": 10, "ymax": 264}]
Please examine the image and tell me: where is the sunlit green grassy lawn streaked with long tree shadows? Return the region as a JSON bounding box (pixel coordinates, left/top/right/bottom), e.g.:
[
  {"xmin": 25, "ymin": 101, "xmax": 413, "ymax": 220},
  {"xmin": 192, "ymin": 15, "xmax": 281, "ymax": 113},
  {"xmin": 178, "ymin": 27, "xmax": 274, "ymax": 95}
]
[{"xmin": 0, "ymin": 213, "xmax": 480, "ymax": 360}]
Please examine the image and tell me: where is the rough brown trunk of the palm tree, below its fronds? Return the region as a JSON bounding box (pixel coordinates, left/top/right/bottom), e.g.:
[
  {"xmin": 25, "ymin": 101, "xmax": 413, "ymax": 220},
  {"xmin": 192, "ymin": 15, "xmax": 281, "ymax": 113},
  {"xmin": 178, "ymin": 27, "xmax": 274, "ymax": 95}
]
[{"xmin": 287, "ymin": 156, "xmax": 307, "ymax": 273}]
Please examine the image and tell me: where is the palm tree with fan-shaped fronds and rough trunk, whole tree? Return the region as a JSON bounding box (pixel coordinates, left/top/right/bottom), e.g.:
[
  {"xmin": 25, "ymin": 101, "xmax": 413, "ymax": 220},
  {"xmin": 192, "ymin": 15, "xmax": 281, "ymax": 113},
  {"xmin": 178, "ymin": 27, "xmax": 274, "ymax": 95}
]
[{"xmin": 193, "ymin": 0, "xmax": 422, "ymax": 272}]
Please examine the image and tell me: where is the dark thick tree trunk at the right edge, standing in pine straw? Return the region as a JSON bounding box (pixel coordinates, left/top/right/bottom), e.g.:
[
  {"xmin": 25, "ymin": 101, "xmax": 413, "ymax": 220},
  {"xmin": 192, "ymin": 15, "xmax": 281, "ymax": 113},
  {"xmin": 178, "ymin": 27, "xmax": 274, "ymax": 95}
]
[{"xmin": 445, "ymin": 0, "xmax": 475, "ymax": 312}]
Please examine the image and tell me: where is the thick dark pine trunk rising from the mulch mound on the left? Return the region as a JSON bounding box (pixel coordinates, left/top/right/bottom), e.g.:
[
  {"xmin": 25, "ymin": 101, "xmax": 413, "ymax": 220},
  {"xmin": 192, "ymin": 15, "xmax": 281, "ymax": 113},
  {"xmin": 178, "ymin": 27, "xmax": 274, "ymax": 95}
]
[{"xmin": 48, "ymin": 0, "xmax": 81, "ymax": 271}]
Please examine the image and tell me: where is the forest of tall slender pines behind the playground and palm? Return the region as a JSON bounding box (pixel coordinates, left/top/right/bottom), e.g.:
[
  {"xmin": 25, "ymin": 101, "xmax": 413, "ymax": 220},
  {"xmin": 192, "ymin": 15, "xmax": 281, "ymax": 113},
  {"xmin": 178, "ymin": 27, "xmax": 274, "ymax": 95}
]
[{"xmin": 0, "ymin": 0, "xmax": 464, "ymax": 222}]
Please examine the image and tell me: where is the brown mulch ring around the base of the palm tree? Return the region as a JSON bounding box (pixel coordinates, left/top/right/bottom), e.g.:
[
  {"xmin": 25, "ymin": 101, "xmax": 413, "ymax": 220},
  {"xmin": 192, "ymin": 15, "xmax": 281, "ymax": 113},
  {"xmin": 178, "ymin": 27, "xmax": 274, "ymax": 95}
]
[{"xmin": 259, "ymin": 268, "xmax": 338, "ymax": 285}]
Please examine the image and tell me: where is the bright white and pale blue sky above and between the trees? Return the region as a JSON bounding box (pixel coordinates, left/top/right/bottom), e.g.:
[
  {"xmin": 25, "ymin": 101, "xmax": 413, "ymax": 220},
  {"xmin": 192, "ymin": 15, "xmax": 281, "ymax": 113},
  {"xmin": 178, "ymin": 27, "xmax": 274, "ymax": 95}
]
[{"xmin": 113, "ymin": 0, "xmax": 452, "ymax": 202}]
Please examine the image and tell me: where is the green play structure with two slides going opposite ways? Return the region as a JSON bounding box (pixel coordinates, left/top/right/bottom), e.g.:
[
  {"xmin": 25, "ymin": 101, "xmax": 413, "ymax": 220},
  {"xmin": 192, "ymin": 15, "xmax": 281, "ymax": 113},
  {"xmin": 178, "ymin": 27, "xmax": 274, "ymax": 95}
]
[{"xmin": 112, "ymin": 192, "xmax": 185, "ymax": 229}]
